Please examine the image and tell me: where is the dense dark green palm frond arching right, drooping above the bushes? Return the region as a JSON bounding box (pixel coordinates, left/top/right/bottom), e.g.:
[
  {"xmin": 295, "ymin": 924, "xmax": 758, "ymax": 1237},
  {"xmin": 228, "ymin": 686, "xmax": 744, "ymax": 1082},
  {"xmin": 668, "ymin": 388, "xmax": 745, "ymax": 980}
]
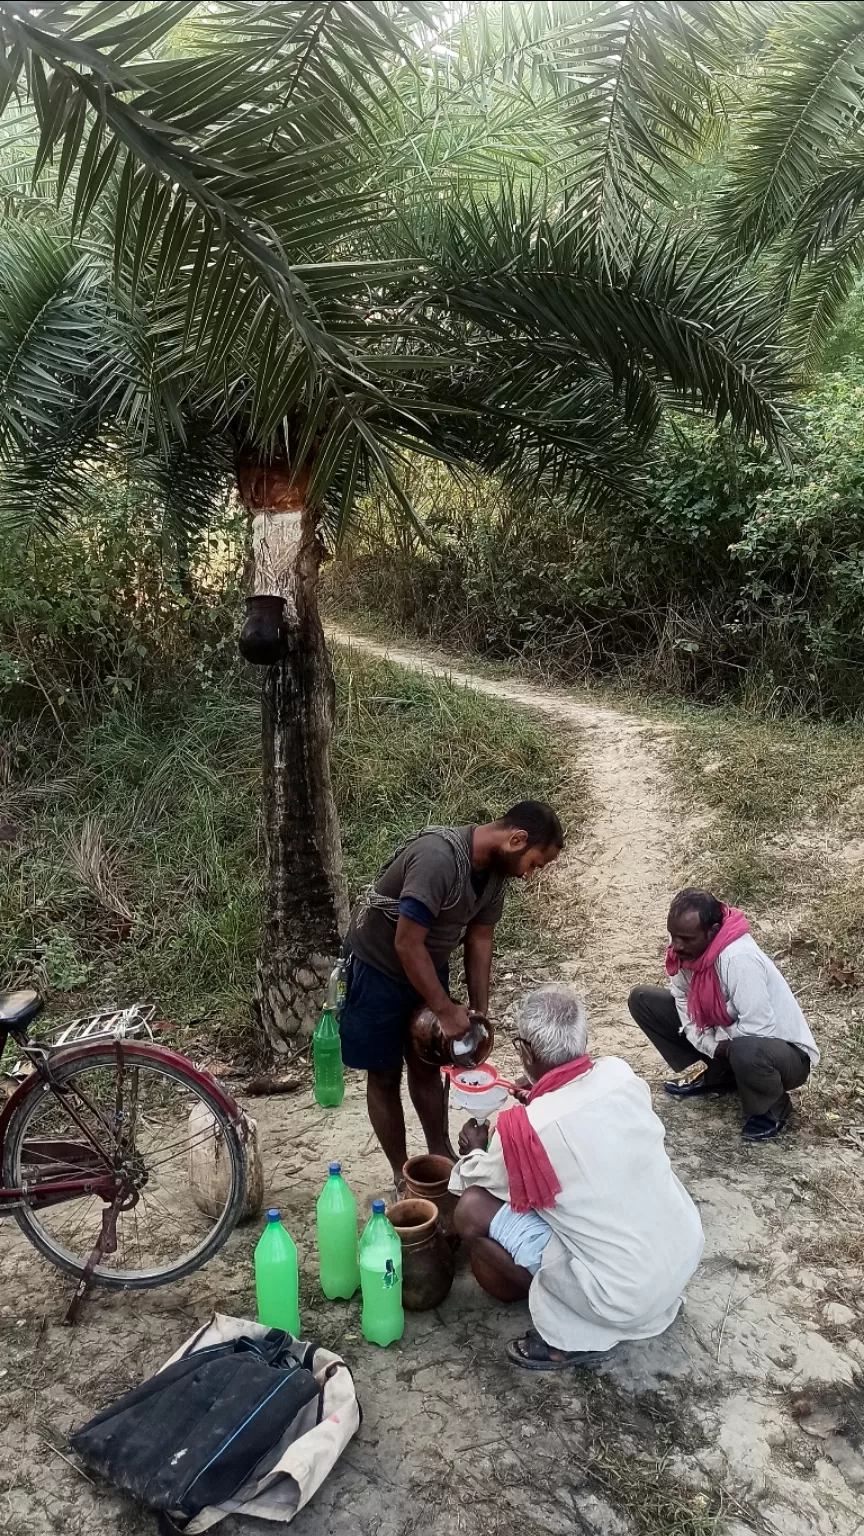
[{"xmin": 415, "ymin": 188, "xmax": 784, "ymax": 442}]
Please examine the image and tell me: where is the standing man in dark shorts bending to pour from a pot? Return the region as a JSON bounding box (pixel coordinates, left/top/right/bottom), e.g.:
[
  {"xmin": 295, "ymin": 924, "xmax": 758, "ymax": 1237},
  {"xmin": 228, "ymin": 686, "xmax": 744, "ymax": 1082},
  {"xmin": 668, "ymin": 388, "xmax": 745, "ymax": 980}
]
[{"xmin": 340, "ymin": 800, "xmax": 564, "ymax": 1187}]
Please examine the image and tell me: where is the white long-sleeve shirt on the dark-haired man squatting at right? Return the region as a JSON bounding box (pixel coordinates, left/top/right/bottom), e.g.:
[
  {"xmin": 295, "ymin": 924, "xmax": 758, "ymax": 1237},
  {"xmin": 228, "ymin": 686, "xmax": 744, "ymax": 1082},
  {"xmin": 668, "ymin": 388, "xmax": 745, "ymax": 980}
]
[{"xmin": 669, "ymin": 934, "xmax": 819, "ymax": 1066}]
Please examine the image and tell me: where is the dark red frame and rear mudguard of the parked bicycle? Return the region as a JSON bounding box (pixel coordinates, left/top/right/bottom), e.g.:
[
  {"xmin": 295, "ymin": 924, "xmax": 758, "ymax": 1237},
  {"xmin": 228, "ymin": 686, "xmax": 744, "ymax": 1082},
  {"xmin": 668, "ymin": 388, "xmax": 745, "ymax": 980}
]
[{"xmin": 0, "ymin": 1031, "xmax": 243, "ymax": 1217}]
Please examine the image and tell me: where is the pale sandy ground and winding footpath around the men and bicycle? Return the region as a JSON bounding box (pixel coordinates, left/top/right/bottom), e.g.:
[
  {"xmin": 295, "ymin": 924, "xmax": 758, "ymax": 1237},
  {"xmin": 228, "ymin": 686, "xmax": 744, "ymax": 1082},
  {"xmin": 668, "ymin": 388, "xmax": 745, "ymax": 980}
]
[{"xmin": 0, "ymin": 636, "xmax": 864, "ymax": 1536}]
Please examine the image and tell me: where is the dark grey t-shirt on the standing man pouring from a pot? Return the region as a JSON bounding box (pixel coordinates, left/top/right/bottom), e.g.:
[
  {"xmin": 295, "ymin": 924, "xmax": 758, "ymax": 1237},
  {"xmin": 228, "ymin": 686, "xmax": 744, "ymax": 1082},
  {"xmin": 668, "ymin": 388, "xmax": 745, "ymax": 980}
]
[{"xmin": 347, "ymin": 826, "xmax": 506, "ymax": 982}]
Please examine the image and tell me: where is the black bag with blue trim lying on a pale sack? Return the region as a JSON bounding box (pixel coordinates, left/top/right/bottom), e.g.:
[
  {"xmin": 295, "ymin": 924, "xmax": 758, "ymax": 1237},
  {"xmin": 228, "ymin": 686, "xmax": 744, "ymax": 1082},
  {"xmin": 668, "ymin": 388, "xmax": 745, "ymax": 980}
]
[{"xmin": 71, "ymin": 1329, "xmax": 321, "ymax": 1530}]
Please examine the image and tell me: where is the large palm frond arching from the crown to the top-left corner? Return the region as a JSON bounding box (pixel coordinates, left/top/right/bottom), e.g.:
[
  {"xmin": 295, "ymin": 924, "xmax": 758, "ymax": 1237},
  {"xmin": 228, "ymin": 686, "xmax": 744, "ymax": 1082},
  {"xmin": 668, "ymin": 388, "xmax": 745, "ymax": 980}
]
[{"xmin": 0, "ymin": 3, "xmax": 414, "ymax": 408}]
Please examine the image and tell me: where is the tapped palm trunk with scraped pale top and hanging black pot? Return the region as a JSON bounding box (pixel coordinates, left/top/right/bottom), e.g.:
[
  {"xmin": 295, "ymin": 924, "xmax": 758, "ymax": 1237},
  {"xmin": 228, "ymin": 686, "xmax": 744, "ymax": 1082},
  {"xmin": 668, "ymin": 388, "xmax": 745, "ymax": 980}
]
[{"xmin": 237, "ymin": 461, "xmax": 347, "ymax": 1052}]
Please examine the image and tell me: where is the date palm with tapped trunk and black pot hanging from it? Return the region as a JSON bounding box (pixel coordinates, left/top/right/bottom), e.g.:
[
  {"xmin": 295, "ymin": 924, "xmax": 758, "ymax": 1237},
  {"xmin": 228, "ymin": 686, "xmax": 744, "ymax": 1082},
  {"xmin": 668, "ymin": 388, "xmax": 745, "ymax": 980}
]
[{"xmin": 0, "ymin": 0, "xmax": 783, "ymax": 1049}]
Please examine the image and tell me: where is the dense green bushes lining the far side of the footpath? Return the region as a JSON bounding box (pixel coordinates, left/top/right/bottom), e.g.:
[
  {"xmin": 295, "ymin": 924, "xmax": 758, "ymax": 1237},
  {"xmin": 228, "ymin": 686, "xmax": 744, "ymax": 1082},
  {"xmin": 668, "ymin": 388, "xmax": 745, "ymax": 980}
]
[{"xmin": 329, "ymin": 362, "xmax": 864, "ymax": 716}]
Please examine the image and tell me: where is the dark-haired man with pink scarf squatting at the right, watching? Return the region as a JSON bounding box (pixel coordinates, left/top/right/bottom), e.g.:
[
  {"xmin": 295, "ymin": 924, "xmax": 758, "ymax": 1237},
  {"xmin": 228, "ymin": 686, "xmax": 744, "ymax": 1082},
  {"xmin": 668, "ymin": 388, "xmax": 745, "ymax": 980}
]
[{"xmin": 629, "ymin": 891, "xmax": 819, "ymax": 1141}]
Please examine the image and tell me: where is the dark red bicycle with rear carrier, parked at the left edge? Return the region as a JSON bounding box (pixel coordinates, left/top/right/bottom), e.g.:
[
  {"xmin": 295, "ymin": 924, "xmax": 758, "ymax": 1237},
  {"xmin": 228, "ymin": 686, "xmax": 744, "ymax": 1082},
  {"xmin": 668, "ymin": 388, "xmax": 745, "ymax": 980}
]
[{"xmin": 0, "ymin": 991, "xmax": 246, "ymax": 1321}]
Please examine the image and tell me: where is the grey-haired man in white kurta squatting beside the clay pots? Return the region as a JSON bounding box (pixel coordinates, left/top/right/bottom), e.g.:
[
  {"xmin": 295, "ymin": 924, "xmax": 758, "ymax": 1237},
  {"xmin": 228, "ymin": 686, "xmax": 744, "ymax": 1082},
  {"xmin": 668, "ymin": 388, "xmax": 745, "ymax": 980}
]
[{"xmin": 450, "ymin": 986, "xmax": 704, "ymax": 1370}]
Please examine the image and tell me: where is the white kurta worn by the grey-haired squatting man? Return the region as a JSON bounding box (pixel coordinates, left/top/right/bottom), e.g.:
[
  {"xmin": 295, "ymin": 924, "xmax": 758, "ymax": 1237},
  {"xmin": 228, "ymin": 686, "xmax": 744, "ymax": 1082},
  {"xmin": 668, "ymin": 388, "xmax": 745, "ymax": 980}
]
[{"xmin": 450, "ymin": 1057, "xmax": 704, "ymax": 1350}]
